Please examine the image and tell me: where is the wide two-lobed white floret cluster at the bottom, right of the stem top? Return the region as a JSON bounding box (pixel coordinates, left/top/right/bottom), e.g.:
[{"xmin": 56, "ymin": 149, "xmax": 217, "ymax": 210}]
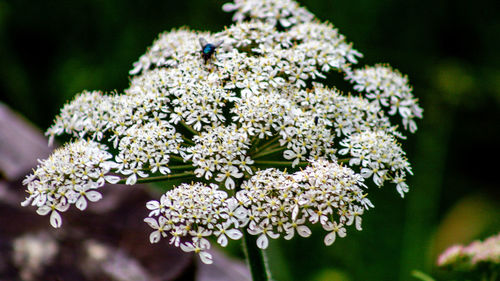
[{"xmin": 236, "ymin": 159, "xmax": 373, "ymax": 249}]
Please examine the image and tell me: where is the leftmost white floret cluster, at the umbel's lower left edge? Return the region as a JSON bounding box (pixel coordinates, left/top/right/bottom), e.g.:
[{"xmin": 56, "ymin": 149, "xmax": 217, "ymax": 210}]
[{"xmin": 22, "ymin": 140, "xmax": 119, "ymax": 228}]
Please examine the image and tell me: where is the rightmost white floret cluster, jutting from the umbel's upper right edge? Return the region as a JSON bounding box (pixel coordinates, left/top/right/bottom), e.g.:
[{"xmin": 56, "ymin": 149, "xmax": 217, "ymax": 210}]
[{"xmin": 347, "ymin": 65, "xmax": 423, "ymax": 133}]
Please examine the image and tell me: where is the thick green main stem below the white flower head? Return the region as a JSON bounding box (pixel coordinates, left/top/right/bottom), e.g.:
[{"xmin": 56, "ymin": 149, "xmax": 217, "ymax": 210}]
[{"xmin": 242, "ymin": 230, "xmax": 271, "ymax": 281}]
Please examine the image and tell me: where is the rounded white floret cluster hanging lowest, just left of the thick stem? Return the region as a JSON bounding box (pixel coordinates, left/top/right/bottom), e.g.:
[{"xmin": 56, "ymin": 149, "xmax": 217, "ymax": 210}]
[{"xmin": 144, "ymin": 183, "xmax": 246, "ymax": 263}]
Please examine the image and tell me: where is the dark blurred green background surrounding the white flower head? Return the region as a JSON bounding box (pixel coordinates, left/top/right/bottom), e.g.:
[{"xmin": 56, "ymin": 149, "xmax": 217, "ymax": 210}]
[{"xmin": 0, "ymin": 0, "xmax": 500, "ymax": 281}]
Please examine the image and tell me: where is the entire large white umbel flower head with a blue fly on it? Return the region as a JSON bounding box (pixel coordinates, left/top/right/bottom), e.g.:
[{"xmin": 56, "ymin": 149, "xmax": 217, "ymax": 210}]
[{"xmin": 23, "ymin": 0, "xmax": 422, "ymax": 263}]
